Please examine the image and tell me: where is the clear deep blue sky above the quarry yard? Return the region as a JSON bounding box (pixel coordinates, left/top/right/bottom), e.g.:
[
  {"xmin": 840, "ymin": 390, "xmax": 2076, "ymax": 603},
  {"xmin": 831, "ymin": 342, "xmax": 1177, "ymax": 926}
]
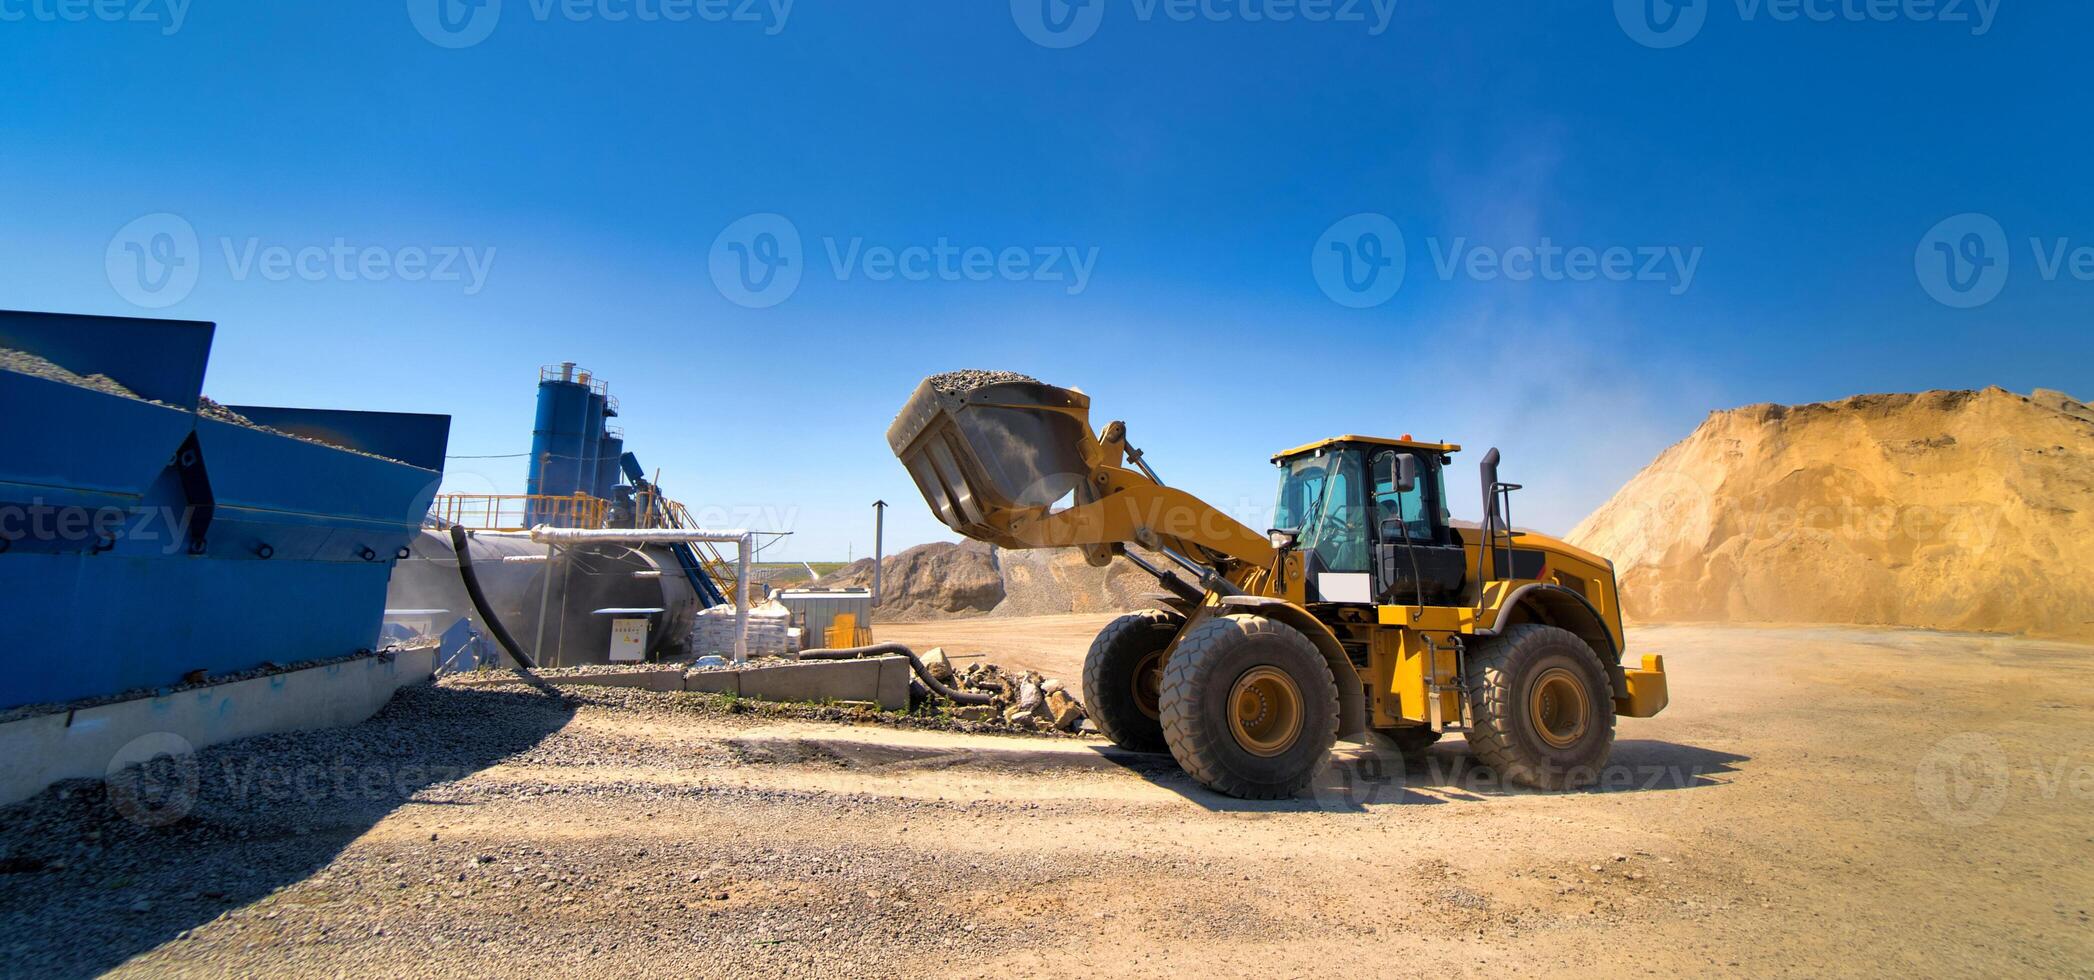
[{"xmin": 0, "ymin": 0, "xmax": 2094, "ymax": 559}]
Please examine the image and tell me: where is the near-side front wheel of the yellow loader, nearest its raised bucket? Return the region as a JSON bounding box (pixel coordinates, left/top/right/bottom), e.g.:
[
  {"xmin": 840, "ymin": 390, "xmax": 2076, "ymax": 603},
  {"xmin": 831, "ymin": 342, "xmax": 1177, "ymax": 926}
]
[{"xmin": 1162, "ymin": 614, "xmax": 1338, "ymax": 800}]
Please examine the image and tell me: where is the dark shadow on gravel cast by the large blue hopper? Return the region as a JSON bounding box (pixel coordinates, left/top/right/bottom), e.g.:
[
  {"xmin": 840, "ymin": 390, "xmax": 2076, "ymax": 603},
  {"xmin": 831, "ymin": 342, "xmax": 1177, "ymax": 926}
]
[{"xmin": 0, "ymin": 685, "xmax": 574, "ymax": 976}]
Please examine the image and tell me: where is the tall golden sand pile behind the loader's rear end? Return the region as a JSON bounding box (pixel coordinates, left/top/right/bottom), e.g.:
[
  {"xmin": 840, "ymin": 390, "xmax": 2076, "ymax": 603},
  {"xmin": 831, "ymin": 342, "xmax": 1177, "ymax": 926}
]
[{"xmin": 1568, "ymin": 387, "xmax": 2094, "ymax": 639}]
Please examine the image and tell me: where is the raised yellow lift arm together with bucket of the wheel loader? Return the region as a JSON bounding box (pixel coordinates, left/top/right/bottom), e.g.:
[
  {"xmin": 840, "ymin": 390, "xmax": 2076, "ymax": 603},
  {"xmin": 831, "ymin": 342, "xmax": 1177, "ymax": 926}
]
[{"xmin": 888, "ymin": 379, "xmax": 1277, "ymax": 595}]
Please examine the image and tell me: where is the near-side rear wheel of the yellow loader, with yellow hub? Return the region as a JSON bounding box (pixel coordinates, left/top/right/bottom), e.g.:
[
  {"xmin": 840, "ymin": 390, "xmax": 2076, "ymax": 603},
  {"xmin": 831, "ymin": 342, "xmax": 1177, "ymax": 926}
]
[{"xmin": 1468, "ymin": 624, "xmax": 1614, "ymax": 789}]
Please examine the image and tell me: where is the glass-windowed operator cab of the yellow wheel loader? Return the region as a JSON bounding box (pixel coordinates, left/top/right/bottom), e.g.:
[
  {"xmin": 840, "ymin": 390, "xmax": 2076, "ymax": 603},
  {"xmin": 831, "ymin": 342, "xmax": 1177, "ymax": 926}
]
[{"xmin": 1273, "ymin": 436, "xmax": 1468, "ymax": 605}]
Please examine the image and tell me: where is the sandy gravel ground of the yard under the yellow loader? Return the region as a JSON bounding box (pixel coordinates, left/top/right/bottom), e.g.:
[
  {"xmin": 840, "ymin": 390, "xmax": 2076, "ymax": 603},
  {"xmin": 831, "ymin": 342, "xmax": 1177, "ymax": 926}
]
[{"xmin": 0, "ymin": 616, "xmax": 2094, "ymax": 978}]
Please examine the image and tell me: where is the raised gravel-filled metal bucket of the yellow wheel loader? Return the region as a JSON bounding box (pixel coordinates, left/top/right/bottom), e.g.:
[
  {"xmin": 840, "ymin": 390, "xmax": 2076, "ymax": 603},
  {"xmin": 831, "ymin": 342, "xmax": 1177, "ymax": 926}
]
[{"xmin": 888, "ymin": 373, "xmax": 1097, "ymax": 549}]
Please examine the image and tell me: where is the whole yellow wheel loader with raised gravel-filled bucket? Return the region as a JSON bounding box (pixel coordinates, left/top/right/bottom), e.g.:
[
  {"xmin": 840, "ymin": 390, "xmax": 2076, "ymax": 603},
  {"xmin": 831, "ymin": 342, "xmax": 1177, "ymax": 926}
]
[{"xmin": 888, "ymin": 373, "xmax": 1667, "ymax": 800}]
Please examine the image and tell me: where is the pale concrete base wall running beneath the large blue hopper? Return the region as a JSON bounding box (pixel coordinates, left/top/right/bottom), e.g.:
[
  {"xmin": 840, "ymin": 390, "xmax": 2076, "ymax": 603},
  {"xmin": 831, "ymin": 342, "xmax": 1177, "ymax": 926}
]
[{"xmin": 0, "ymin": 647, "xmax": 436, "ymax": 806}]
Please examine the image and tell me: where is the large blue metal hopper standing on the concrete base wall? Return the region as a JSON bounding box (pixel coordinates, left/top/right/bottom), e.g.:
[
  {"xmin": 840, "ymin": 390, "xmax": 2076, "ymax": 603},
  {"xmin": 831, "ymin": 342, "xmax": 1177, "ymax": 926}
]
[{"xmin": 0, "ymin": 312, "xmax": 450, "ymax": 710}]
